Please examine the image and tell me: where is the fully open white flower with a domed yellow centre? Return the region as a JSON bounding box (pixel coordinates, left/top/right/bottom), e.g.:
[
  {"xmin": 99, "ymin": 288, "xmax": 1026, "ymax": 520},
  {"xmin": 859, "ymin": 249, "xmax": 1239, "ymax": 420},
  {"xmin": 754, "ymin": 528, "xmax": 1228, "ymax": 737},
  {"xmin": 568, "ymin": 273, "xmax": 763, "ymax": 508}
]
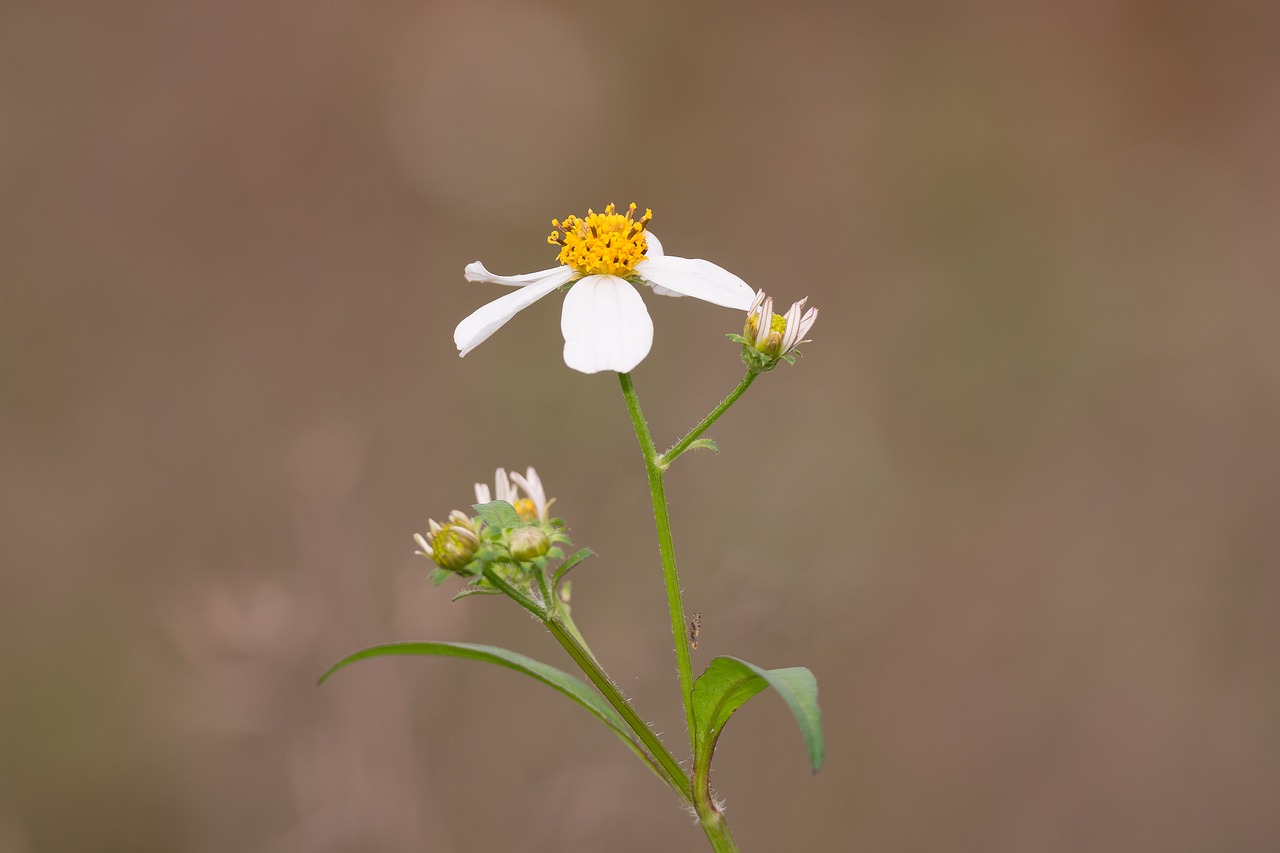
[{"xmin": 453, "ymin": 204, "xmax": 751, "ymax": 373}]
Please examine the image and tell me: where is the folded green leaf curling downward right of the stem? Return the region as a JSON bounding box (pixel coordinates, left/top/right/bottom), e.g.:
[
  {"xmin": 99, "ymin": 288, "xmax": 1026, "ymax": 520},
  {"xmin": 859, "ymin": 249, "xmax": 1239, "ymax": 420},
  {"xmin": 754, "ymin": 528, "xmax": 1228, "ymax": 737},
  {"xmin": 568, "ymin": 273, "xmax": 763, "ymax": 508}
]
[{"xmin": 694, "ymin": 657, "xmax": 826, "ymax": 779}]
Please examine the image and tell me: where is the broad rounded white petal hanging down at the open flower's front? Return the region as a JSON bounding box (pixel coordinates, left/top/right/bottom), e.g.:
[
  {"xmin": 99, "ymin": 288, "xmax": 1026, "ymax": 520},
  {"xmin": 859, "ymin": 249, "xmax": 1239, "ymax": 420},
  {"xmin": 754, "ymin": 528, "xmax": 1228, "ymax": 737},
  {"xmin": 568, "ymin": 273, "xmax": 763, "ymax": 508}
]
[{"xmin": 561, "ymin": 275, "xmax": 653, "ymax": 373}]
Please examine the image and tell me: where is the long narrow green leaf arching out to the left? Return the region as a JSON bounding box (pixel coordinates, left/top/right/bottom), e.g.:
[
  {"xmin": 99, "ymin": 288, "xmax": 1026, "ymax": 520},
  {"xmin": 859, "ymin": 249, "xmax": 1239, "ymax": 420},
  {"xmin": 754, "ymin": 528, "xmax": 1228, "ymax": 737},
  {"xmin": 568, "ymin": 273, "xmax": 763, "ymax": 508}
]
[{"xmin": 316, "ymin": 637, "xmax": 667, "ymax": 783}]
